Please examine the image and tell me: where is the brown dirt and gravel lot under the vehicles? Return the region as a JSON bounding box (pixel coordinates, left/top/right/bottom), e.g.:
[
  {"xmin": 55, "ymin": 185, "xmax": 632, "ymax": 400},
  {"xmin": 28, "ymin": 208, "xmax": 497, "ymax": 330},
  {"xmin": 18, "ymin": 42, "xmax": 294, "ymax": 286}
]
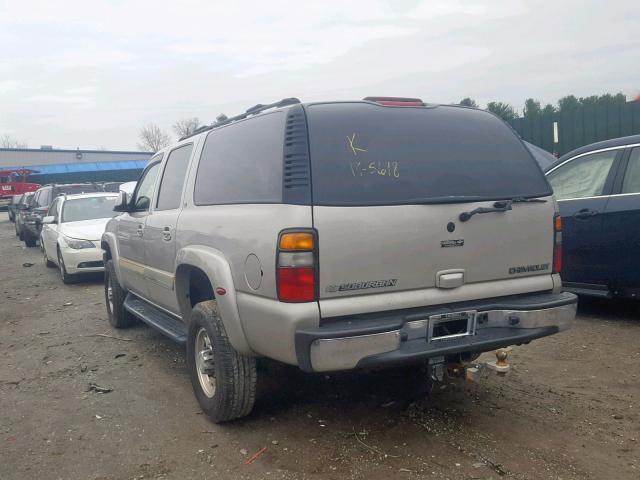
[{"xmin": 0, "ymin": 218, "xmax": 640, "ymax": 480}]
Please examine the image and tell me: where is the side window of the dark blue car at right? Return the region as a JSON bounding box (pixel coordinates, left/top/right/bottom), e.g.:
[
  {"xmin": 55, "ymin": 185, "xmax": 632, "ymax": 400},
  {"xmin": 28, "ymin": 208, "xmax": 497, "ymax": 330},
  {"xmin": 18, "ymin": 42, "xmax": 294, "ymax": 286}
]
[{"xmin": 548, "ymin": 150, "xmax": 618, "ymax": 200}]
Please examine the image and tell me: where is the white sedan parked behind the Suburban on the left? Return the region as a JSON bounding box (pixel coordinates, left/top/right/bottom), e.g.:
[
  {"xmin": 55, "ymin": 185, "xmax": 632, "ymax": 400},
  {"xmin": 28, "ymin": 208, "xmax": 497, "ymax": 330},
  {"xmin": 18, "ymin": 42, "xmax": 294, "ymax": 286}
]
[{"xmin": 40, "ymin": 193, "xmax": 118, "ymax": 283}]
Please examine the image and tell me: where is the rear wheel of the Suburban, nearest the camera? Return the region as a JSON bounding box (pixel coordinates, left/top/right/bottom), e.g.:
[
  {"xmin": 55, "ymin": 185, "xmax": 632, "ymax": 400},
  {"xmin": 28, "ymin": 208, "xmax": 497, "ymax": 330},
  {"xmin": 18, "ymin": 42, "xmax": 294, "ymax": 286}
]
[{"xmin": 187, "ymin": 300, "xmax": 257, "ymax": 423}]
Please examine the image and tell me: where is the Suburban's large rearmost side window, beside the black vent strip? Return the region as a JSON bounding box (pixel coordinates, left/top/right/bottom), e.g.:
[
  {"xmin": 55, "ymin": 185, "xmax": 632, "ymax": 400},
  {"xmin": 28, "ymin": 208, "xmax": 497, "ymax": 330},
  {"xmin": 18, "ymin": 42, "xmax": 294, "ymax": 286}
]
[{"xmin": 194, "ymin": 112, "xmax": 285, "ymax": 205}]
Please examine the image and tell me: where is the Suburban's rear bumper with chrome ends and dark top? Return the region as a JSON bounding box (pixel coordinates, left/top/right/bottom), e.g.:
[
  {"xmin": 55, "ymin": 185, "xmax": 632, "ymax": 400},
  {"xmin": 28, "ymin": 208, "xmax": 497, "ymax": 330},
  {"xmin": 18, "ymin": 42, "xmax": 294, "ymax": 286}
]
[{"xmin": 296, "ymin": 292, "xmax": 578, "ymax": 372}]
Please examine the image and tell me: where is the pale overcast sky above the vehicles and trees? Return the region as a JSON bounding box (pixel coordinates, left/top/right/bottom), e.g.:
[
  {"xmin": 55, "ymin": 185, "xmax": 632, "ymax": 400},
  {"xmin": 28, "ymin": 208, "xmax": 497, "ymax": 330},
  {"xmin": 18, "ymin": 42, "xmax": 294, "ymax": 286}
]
[{"xmin": 0, "ymin": 0, "xmax": 640, "ymax": 150}]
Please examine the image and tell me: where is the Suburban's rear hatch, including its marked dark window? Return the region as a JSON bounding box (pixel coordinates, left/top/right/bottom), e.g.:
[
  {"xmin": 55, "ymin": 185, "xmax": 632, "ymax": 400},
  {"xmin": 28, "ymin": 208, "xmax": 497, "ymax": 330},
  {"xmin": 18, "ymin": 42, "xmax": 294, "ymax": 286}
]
[{"xmin": 306, "ymin": 102, "xmax": 555, "ymax": 317}]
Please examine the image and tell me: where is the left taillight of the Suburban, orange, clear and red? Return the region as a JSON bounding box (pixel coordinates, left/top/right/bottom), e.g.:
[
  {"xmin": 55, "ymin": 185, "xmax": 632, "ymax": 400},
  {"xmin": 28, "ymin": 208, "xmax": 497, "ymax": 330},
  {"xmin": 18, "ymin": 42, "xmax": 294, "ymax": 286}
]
[{"xmin": 276, "ymin": 230, "xmax": 318, "ymax": 302}]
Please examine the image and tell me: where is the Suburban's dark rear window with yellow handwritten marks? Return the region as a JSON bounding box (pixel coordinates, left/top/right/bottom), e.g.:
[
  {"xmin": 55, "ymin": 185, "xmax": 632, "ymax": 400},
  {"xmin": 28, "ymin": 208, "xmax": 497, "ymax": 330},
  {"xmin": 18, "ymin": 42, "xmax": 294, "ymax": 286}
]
[{"xmin": 307, "ymin": 103, "xmax": 551, "ymax": 205}]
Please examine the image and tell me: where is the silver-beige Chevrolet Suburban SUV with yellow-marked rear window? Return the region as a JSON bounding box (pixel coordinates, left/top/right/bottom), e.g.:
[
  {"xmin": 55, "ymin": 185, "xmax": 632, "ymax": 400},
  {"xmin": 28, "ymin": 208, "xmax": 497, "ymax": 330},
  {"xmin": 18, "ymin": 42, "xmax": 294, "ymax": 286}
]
[{"xmin": 102, "ymin": 98, "xmax": 577, "ymax": 422}]
